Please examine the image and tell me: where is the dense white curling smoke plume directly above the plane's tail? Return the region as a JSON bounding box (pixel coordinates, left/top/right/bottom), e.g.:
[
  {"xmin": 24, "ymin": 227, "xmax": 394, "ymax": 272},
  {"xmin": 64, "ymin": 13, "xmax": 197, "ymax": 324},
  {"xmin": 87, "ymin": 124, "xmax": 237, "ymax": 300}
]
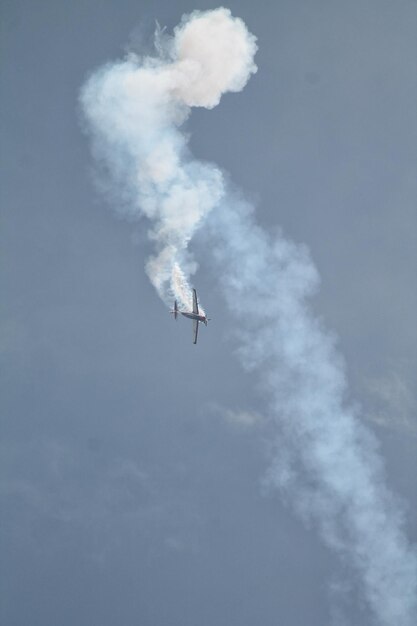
[{"xmin": 81, "ymin": 9, "xmax": 256, "ymax": 307}]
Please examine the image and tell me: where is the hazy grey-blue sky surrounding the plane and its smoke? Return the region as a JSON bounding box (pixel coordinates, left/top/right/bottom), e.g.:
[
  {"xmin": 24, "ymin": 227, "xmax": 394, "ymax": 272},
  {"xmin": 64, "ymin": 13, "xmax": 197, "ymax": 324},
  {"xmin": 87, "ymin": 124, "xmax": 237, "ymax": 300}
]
[{"xmin": 0, "ymin": 0, "xmax": 417, "ymax": 626}]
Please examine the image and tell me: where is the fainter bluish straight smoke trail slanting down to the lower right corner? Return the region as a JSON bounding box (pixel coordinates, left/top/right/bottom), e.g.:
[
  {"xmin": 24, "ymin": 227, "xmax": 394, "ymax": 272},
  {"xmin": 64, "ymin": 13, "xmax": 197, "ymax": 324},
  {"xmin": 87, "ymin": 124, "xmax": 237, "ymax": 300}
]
[{"xmin": 209, "ymin": 193, "xmax": 417, "ymax": 626}]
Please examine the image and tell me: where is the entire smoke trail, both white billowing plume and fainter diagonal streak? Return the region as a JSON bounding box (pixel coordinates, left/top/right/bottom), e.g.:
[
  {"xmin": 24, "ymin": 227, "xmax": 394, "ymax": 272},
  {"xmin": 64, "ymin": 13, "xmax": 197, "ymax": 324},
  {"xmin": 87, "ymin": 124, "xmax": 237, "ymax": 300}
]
[{"xmin": 81, "ymin": 8, "xmax": 417, "ymax": 626}]
